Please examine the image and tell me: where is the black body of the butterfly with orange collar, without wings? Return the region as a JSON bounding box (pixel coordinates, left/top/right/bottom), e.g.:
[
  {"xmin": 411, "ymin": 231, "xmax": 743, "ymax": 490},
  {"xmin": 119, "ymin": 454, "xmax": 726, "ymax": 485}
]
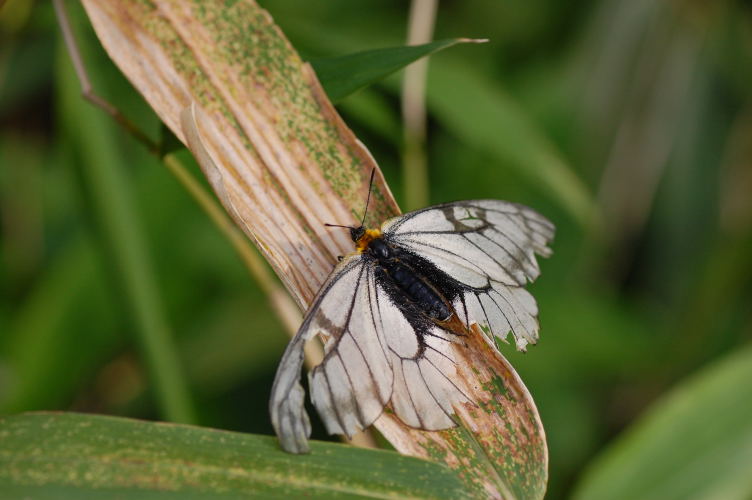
[{"xmin": 357, "ymin": 230, "xmax": 452, "ymax": 321}]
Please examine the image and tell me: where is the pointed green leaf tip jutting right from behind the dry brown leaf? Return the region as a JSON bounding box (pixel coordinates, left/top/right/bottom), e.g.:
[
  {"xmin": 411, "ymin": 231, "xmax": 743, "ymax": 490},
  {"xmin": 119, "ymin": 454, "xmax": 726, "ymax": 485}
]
[{"xmin": 310, "ymin": 38, "xmax": 485, "ymax": 104}]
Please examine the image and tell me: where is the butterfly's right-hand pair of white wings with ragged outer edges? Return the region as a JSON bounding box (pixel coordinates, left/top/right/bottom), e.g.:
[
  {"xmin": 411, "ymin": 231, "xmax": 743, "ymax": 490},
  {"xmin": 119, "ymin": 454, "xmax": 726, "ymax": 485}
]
[{"xmin": 382, "ymin": 200, "xmax": 554, "ymax": 351}]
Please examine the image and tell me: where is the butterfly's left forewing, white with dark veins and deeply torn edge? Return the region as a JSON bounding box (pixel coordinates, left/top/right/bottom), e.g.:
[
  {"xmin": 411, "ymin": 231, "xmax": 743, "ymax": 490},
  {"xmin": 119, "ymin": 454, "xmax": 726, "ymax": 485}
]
[{"xmin": 269, "ymin": 255, "xmax": 392, "ymax": 453}]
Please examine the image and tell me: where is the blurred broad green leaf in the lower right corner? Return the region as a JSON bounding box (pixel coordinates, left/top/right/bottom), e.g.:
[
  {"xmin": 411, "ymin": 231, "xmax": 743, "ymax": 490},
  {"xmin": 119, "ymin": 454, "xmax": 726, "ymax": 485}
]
[{"xmin": 574, "ymin": 347, "xmax": 752, "ymax": 500}]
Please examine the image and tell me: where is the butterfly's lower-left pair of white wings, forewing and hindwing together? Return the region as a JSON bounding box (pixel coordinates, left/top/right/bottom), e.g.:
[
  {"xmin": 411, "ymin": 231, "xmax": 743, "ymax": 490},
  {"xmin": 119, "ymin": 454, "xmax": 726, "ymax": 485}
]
[{"xmin": 270, "ymin": 255, "xmax": 469, "ymax": 453}]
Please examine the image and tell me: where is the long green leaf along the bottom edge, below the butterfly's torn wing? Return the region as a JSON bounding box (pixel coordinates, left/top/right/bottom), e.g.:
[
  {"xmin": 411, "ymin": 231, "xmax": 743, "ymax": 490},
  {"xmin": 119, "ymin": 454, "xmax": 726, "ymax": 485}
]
[{"xmin": 0, "ymin": 413, "xmax": 467, "ymax": 499}]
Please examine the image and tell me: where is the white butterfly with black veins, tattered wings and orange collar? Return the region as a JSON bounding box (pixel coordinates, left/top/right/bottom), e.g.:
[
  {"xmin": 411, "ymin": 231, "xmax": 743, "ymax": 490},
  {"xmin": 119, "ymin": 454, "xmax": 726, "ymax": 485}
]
[{"xmin": 269, "ymin": 172, "xmax": 554, "ymax": 453}]
